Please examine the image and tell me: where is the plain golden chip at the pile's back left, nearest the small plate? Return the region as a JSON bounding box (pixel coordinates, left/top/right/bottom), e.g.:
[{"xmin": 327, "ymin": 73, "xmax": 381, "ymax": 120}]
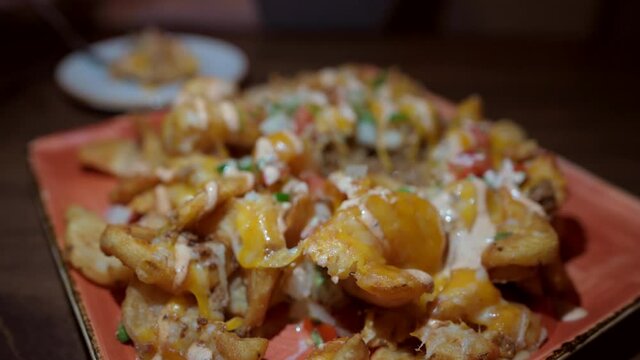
[{"xmin": 78, "ymin": 139, "xmax": 150, "ymax": 176}]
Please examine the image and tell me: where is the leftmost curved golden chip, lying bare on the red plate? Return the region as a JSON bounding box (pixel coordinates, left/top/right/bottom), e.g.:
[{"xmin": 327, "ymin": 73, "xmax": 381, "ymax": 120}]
[{"xmin": 65, "ymin": 206, "xmax": 131, "ymax": 286}]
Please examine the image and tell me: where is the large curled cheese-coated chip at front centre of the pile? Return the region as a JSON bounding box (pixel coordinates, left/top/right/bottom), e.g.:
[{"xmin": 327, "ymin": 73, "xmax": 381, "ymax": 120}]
[{"xmin": 302, "ymin": 193, "xmax": 444, "ymax": 307}]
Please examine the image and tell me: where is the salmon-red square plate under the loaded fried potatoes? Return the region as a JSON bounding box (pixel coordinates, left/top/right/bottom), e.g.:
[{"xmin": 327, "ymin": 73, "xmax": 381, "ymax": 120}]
[{"xmin": 29, "ymin": 108, "xmax": 640, "ymax": 359}]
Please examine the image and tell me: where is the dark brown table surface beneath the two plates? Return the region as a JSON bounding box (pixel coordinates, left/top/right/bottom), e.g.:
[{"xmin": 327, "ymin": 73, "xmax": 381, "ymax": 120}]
[{"xmin": 0, "ymin": 29, "xmax": 640, "ymax": 359}]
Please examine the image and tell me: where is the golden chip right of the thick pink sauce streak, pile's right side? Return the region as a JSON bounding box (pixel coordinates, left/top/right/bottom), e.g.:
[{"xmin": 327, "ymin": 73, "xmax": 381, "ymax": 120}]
[{"xmin": 482, "ymin": 189, "xmax": 559, "ymax": 280}]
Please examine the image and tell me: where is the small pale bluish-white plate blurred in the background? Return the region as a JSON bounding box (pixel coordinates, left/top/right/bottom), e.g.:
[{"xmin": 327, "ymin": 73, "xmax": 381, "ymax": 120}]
[{"xmin": 56, "ymin": 34, "xmax": 248, "ymax": 111}]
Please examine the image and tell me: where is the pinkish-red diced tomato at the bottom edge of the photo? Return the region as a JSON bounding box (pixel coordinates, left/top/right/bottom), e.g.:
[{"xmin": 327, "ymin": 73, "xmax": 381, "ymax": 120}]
[{"xmin": 265, "ymin": 319, "xmax": 337, "ymax": 360}]
